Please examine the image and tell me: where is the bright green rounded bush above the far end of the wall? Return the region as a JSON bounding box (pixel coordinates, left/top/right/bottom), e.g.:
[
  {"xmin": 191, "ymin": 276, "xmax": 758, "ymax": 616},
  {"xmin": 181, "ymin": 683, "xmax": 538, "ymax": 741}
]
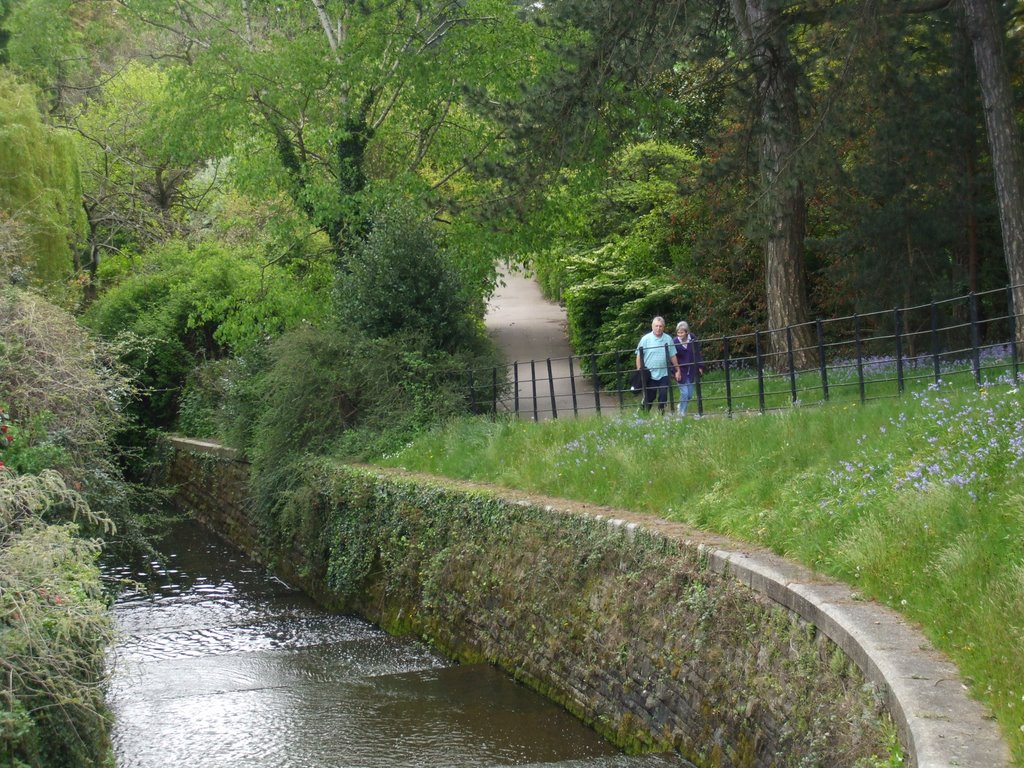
[{"xmin": 84, "ymin": 241, "xmax": 329, "ymax": 428}]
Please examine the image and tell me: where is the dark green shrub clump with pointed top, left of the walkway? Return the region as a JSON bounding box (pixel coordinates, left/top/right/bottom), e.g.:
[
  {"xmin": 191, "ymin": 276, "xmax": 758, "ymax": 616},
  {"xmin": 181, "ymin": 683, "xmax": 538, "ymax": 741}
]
[{"xmin": 232, "ymin": 208, "xmax": 499, "ymax": 544}]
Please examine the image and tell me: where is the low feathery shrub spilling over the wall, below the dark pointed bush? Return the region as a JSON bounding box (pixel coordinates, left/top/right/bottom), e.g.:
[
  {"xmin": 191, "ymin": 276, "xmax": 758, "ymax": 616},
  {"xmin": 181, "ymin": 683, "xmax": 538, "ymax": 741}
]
[{"xmin": 235, "ymin": 319, "xmax": 495, "ymax": 529}]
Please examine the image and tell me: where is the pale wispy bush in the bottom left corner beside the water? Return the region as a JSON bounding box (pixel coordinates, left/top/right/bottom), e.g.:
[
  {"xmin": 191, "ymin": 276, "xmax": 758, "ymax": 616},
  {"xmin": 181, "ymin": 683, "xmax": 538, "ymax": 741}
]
[{"xmin": 0, "ymin": 469, "xmax": 112, "ymax": 768}]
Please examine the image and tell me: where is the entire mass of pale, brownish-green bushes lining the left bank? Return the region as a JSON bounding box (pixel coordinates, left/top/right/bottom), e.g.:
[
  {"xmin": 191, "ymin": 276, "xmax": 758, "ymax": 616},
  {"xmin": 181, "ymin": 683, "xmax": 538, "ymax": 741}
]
[{"xmin": 0, "ymin": 288, "xmax": 128, "ymax": 768}]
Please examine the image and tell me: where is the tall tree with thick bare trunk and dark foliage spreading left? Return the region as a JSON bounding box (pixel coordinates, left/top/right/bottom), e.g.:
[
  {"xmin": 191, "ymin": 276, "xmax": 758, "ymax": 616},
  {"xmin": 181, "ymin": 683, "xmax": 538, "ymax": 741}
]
[{"xmin": 512, "ymin": 0, "xmax": 813, "ymax": 365}]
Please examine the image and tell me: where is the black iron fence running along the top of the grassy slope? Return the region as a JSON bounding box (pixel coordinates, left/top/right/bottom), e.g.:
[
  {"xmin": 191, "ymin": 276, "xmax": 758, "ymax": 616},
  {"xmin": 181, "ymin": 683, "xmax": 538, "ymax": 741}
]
[{"xmin": 465, "ymin": 287, "xmax": 1021, "ymax": 420}]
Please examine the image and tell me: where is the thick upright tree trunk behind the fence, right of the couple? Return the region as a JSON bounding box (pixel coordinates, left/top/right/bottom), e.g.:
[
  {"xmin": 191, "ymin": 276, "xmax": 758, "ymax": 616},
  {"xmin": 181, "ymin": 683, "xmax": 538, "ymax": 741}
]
[{"xmin": 732, "ymin": 0, "xmax": 816, "ymax": 369}]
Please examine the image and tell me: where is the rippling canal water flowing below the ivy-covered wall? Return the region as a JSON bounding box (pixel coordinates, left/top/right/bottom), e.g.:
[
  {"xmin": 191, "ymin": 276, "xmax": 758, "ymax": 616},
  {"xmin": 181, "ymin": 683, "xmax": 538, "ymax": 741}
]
[{"xmin": 105, "ymin": 522, "xmax": 688, "ymax": 768}]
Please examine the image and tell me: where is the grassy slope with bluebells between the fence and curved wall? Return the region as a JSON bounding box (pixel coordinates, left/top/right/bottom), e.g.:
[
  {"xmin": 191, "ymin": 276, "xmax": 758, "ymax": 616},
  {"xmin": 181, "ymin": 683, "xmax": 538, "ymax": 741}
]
[{"xmin": 381, "ymin": 376, "xmax": 1024, "ymax": 766}]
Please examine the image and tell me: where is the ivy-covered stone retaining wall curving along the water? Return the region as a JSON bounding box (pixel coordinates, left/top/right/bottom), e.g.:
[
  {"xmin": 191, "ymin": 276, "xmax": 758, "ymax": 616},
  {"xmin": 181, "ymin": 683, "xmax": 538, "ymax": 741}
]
[{"xmin": 163, "ymin": 442, "xmax": 893, "ymax": 768}]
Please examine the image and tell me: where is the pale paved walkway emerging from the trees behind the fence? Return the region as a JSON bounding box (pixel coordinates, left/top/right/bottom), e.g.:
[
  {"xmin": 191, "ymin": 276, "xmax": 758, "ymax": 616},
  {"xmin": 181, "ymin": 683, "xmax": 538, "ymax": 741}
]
[{"xmin": 484, "ymin": 271, "xmax": 618, "ymax": 420}]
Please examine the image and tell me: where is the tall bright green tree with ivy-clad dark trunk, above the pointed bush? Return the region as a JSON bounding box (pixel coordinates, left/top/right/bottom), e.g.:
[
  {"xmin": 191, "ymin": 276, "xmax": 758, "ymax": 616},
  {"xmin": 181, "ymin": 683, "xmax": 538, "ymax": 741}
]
[{"xmin": 117, "ymin": 0, "xmax": 529, "ymax": 265}]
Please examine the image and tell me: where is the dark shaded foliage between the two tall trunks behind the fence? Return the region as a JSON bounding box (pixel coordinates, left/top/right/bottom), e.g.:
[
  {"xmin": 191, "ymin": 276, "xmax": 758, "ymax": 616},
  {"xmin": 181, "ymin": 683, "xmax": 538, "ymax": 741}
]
[{"xmin": 808, "ymin": 7, "xmax": 1005, "ymax": 314}]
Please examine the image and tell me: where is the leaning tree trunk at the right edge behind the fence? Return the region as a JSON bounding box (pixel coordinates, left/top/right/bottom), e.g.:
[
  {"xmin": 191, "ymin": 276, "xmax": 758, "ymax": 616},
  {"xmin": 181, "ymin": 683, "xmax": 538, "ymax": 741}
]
[{"xmin": 961, "ymin": 0, "xmax": 1024, "ymax": 344}]
